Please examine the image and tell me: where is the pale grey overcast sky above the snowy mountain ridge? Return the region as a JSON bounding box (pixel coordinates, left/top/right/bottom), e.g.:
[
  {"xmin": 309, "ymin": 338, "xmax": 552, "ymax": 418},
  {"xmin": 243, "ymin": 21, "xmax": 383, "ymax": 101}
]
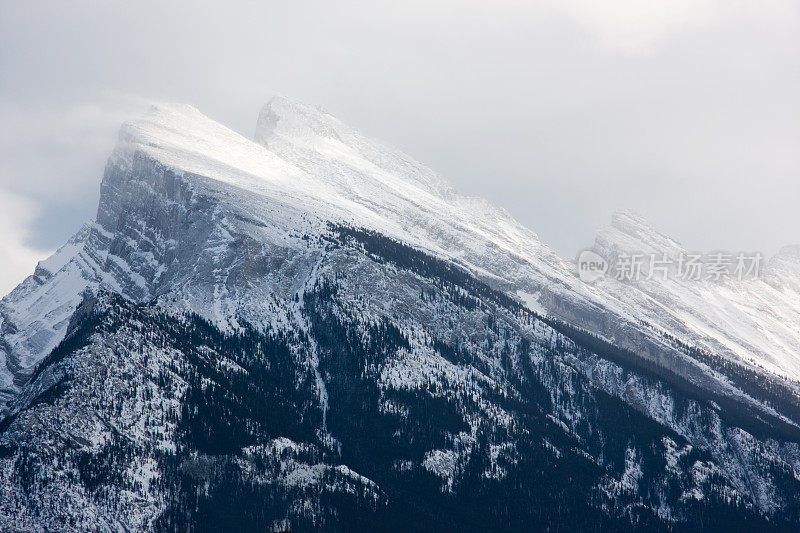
[{"xmin": 0, "ymin": 0, "xmax": 800, "ymax": 294}]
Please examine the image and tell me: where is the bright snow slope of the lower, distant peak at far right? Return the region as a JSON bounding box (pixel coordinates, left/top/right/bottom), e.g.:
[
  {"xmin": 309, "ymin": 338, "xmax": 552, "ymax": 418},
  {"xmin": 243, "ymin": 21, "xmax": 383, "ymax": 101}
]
[{"xmin": 594, "ymin": 213, "xmax": 800, "ymax": 380}]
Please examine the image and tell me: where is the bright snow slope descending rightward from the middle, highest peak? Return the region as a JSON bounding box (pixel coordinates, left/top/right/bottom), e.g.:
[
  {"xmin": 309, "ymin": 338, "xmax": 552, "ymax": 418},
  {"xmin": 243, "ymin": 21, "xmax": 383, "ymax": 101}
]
[{"xmin": 255, "ymin": 98, "xmax": 565, "ymax": 280}]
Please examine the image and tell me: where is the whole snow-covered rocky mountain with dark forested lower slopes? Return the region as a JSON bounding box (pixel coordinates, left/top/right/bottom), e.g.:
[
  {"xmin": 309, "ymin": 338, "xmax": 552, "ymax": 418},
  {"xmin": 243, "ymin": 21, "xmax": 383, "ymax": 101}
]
[{"xmin": 0, "ymin": 99, "xmax": 800, "ymax": 531}]
